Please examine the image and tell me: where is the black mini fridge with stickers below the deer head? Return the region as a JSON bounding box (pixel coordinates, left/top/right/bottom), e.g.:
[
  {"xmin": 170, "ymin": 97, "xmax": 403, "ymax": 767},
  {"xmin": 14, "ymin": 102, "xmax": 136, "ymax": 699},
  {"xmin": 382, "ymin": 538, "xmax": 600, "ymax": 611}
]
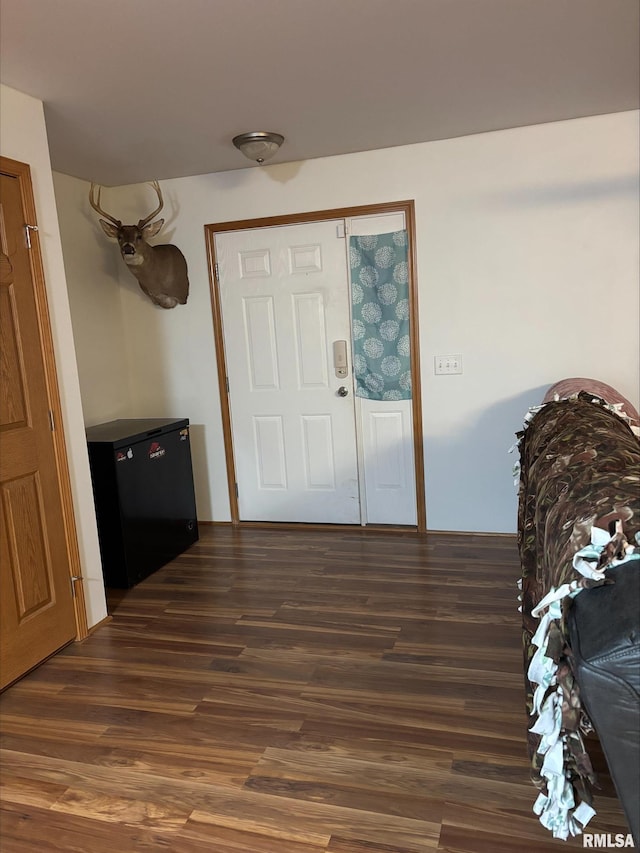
[{"xmin": 86, "ymin": 418, "xmax": 198, "ymax": 589}]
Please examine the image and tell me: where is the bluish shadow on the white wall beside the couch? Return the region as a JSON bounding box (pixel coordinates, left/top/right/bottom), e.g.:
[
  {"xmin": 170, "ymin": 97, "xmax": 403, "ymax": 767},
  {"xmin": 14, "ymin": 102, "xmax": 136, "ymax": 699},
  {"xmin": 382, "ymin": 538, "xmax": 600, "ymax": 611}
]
[{"xmin": 425, "ymin": 385, "xmax": 549, "ymax": 533}]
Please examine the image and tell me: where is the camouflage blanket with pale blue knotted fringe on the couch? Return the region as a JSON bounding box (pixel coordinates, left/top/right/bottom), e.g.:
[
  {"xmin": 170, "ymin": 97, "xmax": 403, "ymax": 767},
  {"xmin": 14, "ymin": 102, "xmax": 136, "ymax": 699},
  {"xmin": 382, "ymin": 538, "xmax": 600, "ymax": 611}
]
[{"xmin": 518, "ymin": 392, "xmax": 640, "ymax": 838}]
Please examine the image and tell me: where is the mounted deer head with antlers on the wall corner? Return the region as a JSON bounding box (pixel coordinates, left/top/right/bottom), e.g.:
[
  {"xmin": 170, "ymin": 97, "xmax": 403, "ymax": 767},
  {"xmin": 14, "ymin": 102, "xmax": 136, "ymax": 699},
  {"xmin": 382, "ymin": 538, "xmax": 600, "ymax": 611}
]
[{"xmin": 89, "ymin": 181, "xmax": 189, "ymax": 308}]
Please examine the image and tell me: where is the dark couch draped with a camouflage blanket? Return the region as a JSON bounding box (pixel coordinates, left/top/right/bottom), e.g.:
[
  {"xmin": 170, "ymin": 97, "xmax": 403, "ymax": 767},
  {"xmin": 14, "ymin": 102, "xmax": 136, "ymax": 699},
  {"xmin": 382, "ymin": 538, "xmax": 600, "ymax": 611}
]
[{"xmin": 518, "ymin": 380, "xmax": 640, "ymax": 844}]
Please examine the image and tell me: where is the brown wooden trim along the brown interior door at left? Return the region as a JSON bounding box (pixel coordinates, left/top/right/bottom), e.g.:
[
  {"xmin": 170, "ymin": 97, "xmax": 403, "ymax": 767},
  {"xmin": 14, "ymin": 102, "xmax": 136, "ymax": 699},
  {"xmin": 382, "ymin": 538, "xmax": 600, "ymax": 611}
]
[{"xmin": 0, "ymin": 157, "xmax": 89, "ymax": 640}]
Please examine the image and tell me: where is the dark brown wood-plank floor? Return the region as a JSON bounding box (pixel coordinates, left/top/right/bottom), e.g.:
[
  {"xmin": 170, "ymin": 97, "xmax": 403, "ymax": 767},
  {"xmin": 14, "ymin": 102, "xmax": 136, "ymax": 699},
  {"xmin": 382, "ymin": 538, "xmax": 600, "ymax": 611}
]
[{"xmin": 0, "ymin": 527, "xmax": 627, "ymax": 853}]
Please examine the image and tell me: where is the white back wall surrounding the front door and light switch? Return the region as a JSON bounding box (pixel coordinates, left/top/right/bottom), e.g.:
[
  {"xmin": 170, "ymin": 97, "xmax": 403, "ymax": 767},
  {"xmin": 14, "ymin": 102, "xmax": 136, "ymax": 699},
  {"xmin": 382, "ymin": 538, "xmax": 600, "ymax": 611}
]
[{"xmin": 55, "ymin": 112, "xmax": 640, "ymax": 532}]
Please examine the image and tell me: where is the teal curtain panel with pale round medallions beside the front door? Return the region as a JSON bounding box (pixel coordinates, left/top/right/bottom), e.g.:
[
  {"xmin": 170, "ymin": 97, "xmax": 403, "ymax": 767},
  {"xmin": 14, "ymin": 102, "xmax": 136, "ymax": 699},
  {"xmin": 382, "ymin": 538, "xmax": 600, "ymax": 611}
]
[{"xmin": 349, "ymin": 231, "xmax": 411, "ymax": 400}]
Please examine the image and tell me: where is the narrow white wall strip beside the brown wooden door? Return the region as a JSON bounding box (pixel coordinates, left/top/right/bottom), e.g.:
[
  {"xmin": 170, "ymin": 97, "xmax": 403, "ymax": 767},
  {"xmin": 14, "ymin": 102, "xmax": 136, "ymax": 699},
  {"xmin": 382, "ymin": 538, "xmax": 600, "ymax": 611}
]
[{"xmin": 0, "ymin": 86, "xmax": 107, "ymax": 627}]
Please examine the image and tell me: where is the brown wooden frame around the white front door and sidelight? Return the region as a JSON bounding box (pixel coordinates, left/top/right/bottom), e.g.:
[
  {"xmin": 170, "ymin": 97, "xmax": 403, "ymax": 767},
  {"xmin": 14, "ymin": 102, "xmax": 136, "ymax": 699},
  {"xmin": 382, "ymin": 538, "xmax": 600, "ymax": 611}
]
[{"xmin": 204, "ymin": 199, "xmax": 427, "ymax": 533}]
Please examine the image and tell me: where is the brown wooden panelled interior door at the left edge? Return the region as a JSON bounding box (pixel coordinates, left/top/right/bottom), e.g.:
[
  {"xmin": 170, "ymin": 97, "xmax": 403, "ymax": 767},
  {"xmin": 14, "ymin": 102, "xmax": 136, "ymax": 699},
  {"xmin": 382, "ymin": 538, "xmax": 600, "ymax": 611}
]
[{"xmin": 0, "ymin": 158, "xmax": 77, "ymax": 687}]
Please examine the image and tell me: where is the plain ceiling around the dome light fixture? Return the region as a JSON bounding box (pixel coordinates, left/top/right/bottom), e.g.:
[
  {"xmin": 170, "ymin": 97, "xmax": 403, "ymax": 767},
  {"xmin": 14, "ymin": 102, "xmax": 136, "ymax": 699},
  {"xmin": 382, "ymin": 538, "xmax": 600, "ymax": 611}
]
[{"xmin": 0, "ymin": 0, "xmax": 640, "ymax": 185}]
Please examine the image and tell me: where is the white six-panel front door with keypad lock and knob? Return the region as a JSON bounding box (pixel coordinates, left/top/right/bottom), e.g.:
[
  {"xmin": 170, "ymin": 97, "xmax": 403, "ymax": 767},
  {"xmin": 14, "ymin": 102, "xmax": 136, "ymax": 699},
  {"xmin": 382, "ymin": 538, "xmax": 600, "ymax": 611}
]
[{"xmin": 215, "ymin": 220, "xmax": 361, "ymax": 524}]
